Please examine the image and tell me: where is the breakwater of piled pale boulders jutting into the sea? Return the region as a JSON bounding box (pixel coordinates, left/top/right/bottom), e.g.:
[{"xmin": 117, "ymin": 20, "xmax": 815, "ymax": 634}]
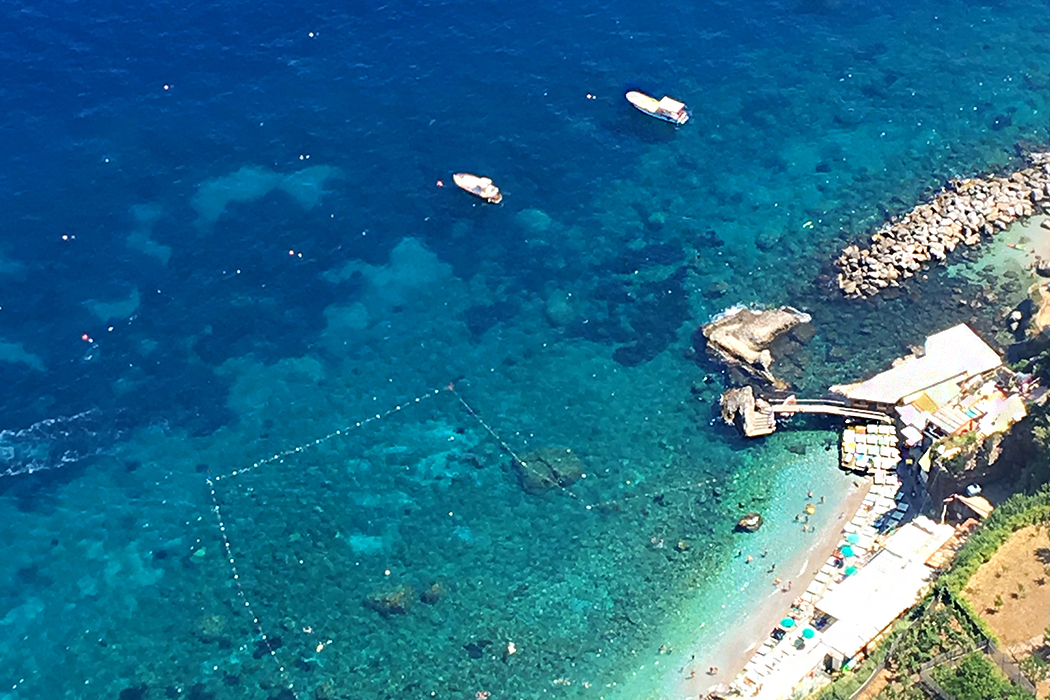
[{"xmin": 836, "ymin": 152, "xmax": 1050, "ymax": 298}]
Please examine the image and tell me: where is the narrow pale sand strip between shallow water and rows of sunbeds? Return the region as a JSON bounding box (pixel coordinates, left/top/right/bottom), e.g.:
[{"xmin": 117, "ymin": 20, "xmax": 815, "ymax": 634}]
[{"xmin": 670, "ymin": 478, "xmax": 872, "ymax": 698}]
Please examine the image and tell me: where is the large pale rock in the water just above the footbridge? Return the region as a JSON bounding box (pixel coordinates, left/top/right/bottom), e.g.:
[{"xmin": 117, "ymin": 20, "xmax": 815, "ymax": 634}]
[{"xmin": 700, "ymin": 306, "xmax": 811, "ymax": 388}]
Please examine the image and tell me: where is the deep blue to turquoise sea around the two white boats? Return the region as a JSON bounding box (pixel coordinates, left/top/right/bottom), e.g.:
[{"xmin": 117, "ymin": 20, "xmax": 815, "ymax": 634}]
[{"xmin": 0, "ymin": 0, "xmax": 1050, "ymax": 700}]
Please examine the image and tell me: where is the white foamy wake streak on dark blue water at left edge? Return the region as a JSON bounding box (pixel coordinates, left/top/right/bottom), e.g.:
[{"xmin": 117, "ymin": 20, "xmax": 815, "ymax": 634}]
[{"xmin": 0, "ymin": 408, "xmax": 102, "ymax": 478}]
